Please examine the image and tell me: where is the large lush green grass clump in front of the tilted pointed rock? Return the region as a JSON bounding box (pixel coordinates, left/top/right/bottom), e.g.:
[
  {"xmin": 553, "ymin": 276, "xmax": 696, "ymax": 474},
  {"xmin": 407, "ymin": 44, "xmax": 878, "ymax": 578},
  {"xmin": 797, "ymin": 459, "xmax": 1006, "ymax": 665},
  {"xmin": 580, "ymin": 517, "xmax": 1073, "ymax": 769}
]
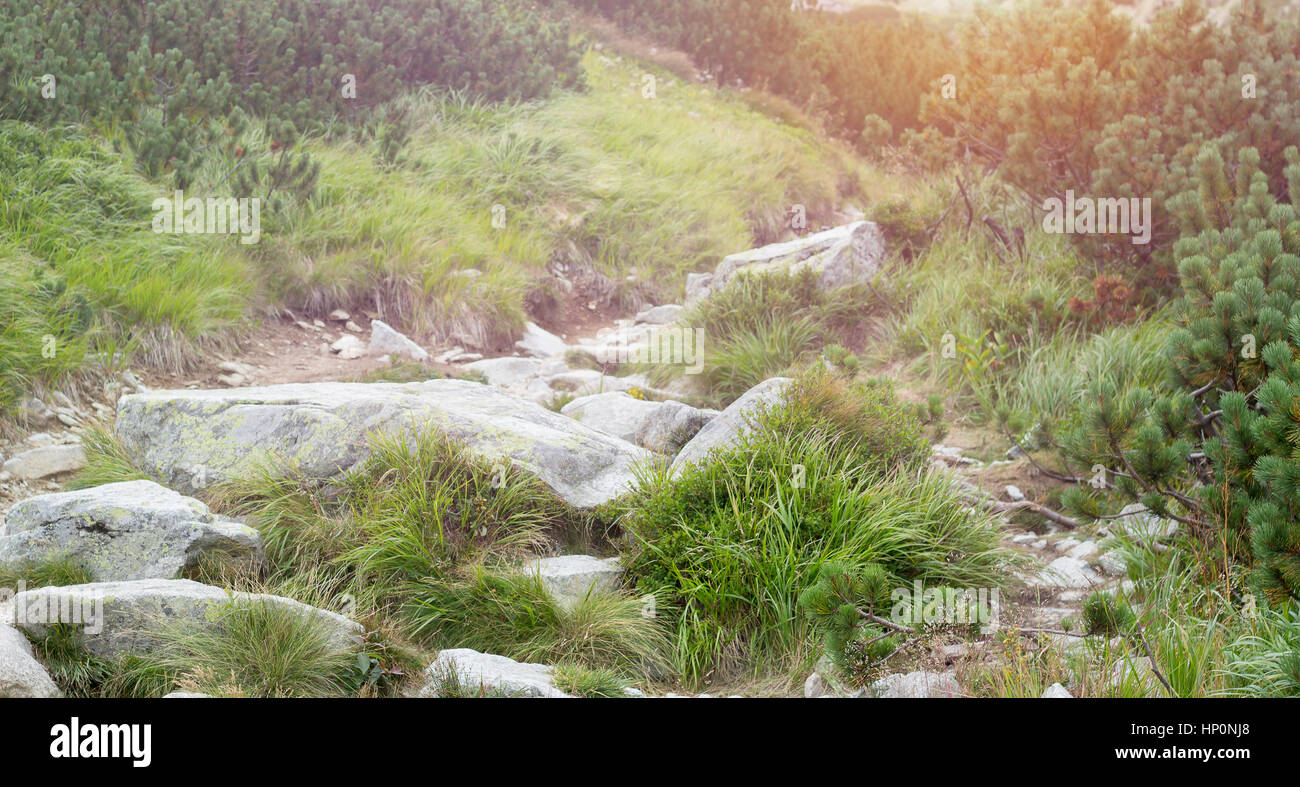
[{"xmin": 623, "ymin": 372, "xmax": 1004, "ymax": 682}]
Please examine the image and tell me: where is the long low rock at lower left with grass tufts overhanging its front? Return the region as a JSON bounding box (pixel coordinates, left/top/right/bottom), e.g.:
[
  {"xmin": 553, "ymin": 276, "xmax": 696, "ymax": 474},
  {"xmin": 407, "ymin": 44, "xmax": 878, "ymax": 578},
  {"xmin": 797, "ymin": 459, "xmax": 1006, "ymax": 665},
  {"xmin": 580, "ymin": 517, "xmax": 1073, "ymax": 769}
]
[{"xmin": 13, "ymin": 579, "xmax": 365, "ymax": 657}]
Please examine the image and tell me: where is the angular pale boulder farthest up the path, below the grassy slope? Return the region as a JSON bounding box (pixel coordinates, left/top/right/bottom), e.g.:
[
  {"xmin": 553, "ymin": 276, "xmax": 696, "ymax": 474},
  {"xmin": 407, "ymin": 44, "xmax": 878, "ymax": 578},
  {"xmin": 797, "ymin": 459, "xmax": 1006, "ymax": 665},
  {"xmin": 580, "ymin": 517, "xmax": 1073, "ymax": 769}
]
[{"xmin": 686, "ymin": 221, "xmax": 885, "ymax": 303}]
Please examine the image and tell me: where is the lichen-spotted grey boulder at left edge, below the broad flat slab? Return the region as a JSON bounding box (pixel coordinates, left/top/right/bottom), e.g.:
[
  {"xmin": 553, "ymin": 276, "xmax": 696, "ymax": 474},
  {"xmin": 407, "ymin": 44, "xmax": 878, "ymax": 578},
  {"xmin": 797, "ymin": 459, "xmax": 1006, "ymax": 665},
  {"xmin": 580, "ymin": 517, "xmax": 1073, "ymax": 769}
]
[{"xmin": 0, "ymin": 481, "xmax": 263, "ymax": 581}]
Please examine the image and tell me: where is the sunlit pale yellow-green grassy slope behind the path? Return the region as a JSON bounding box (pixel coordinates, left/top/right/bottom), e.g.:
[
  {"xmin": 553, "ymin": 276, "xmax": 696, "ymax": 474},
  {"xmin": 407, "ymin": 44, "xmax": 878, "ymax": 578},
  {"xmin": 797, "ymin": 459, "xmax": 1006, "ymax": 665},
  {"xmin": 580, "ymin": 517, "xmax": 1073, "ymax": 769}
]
[{"xmin": 240, "ymin": 52, "xmax": 859, "ymax": 347}]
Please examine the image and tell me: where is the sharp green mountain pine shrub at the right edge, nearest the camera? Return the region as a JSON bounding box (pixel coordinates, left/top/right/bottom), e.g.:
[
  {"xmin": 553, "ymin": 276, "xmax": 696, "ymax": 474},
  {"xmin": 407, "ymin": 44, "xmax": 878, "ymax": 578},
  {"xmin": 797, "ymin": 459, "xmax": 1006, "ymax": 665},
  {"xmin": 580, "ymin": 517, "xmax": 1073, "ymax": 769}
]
[{"xmin": 1062, "ymin": 144, "xmax": 1300, "ymax": 605}]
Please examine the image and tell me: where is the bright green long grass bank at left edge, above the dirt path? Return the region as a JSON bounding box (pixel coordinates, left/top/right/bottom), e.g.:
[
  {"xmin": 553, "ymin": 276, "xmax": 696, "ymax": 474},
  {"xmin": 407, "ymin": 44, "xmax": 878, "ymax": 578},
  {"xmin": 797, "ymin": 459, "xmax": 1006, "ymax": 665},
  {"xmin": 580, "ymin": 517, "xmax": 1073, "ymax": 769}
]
[{"xmin": 0, "ymin": 121, "xmax": 251, "ymax": 411}]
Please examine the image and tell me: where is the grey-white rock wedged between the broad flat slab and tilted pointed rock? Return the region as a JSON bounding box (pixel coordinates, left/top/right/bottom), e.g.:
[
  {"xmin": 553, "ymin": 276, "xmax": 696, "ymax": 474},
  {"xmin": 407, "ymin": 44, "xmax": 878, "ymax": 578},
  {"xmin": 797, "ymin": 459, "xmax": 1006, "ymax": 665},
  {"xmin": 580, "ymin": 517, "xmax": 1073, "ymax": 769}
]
[{"xmin": 560, "ymin": 392, "xmax": 719, "ymax": 455}]
